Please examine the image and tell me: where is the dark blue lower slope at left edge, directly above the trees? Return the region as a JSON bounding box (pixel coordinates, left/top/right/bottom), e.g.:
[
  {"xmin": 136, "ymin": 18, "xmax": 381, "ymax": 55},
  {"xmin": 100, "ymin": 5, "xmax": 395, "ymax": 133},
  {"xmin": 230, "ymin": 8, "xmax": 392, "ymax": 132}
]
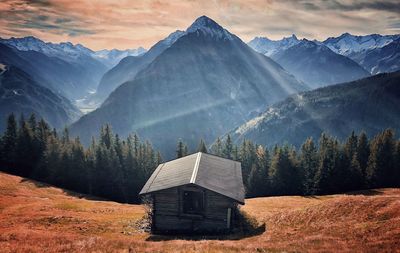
[{"xmin": 0, "ymin": 64, "xmax": 81, "ymax": 131}]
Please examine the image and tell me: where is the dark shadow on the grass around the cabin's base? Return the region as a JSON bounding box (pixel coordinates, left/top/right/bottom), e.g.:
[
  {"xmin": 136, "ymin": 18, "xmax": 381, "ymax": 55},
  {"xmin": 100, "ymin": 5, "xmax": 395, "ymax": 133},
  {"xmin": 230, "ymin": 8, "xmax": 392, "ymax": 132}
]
[{"xmin": 146, "ymin": 211, "xmax": 266, "ymax": 242}]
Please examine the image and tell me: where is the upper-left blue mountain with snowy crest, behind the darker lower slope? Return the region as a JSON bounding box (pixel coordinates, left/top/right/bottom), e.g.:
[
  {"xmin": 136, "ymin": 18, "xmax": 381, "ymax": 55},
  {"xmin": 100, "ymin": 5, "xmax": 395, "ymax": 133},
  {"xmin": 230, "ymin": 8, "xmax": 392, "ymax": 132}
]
[{"xmin": 0, "ymin": 38, "xmax": 107, "ymax": 100}]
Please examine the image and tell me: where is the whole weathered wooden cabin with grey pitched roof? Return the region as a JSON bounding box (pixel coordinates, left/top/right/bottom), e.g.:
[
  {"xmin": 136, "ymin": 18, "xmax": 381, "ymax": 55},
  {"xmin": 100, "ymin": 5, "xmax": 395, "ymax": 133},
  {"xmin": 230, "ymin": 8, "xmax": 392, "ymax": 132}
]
[{"xmin": 139, "ymin": 152, "xmax": 244, "ymax": 233}]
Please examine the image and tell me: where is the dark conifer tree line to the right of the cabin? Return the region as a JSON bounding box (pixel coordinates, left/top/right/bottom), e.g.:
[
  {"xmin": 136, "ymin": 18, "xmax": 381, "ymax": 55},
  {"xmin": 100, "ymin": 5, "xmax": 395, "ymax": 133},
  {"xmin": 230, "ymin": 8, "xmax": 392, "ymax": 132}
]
[{"xmin": 199, "ymin": 129, "xmax": 400, "ymax": 197}]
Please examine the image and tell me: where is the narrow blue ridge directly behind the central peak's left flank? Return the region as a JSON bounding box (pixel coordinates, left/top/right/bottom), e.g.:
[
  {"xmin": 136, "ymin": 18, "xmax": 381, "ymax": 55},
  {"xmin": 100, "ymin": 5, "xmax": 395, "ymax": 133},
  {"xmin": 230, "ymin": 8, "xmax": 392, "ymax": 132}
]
[{"xmin": 94, "ymin": 31, "xmax": 184, "ymax": 102}]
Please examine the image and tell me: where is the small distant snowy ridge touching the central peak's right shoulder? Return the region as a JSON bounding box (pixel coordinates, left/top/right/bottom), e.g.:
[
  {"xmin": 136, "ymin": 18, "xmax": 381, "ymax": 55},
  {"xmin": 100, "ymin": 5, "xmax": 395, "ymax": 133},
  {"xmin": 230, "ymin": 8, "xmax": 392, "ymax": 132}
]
[{"xmin": 248, "ymin": 34, "xmax": 300, "ymax": 56}]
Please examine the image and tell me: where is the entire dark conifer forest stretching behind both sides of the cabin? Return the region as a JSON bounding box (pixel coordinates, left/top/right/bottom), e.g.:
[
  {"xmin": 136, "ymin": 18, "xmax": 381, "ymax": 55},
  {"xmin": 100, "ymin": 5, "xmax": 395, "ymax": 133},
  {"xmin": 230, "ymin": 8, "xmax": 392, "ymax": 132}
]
[{"xmin": 0, "ymin": 114, "xmax": 400, "ymax": 203}]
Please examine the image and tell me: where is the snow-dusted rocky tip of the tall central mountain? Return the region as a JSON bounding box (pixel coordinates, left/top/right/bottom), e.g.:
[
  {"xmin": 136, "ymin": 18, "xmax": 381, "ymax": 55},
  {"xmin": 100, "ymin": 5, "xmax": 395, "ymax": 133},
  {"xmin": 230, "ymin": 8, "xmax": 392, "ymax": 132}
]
[{"xmin": 186, "ymin": 16, "xmax": 233, "ymax": 40}]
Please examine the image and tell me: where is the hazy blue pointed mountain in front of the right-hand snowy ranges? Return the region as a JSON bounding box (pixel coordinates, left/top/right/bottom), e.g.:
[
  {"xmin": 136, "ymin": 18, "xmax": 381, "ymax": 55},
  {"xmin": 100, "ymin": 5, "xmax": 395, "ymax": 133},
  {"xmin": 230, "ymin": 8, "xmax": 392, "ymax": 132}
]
[{"xmin": 271, "ymin": 39, "xmax": 369, "ymax": 88}]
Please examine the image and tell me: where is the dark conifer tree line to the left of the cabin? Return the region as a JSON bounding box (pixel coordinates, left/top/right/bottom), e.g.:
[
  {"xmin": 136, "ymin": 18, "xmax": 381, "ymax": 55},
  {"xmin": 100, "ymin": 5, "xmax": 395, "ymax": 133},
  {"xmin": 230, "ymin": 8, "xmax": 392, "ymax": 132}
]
[{"xmin": 0, "ymin": 114, "xmax": 161, "ymax": 203}]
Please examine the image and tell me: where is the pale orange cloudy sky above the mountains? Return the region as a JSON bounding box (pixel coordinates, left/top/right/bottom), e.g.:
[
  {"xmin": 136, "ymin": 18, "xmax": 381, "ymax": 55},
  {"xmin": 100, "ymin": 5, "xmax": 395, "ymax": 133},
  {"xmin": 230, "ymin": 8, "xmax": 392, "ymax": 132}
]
[{"xmin": 0, "ymin": 0, "xmax": 400, "ymax": 50}]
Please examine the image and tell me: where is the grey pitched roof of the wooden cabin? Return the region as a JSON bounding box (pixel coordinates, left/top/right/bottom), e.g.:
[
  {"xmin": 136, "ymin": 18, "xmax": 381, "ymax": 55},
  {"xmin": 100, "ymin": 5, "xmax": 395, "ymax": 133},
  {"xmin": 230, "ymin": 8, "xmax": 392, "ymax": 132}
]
[{"xmin": 139, "ymin": 152, "xmax": 244, "ymax": 204}]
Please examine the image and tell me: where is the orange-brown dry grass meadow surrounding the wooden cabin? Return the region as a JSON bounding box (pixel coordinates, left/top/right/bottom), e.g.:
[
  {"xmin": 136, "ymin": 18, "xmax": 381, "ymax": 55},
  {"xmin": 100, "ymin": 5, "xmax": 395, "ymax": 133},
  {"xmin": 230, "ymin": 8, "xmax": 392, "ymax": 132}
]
[{"xmin": 0, "ymin": 173, "xmax": 400, "ymax": 252}]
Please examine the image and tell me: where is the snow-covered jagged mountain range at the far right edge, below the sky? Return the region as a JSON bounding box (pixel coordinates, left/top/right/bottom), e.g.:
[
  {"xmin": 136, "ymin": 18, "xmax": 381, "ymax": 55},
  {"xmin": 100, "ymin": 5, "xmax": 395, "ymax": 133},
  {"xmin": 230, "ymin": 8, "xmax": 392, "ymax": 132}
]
[{"xmin": 322, "ymin": 33, "xmax": 400, "ymax": 56}]
